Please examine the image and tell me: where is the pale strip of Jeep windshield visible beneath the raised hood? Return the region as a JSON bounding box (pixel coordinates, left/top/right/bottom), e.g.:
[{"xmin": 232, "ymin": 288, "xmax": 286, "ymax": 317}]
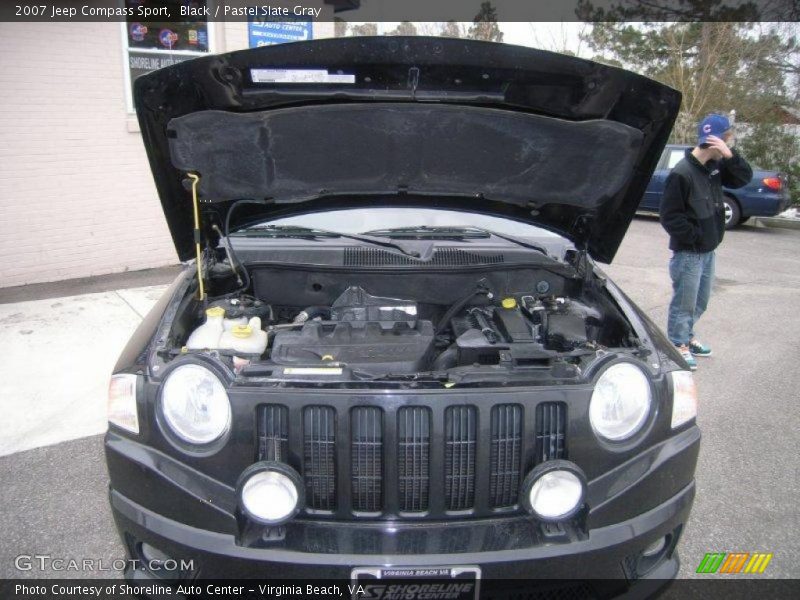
[{"xmin": 244, "ymin": 207, "xmax": 561, "ymax": 240}]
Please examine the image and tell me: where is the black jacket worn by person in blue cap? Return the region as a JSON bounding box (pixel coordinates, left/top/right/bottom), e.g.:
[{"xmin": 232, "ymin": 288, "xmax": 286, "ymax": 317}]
[{"xmin": 660, "ymin": 148, "xmax": 753, "ymax": 252}]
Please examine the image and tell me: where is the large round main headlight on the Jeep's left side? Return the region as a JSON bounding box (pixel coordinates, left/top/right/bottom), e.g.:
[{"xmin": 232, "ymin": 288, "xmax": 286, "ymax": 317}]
[{"xmin": 161, "ymin": 365, "xmax": 231, "ymax": 444}]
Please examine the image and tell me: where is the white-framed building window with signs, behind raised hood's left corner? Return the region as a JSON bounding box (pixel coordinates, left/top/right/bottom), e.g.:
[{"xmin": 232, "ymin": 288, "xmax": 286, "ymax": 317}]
[{"xmin": 122, "ymin": 0, "xmax": 214, "ymax": 113}]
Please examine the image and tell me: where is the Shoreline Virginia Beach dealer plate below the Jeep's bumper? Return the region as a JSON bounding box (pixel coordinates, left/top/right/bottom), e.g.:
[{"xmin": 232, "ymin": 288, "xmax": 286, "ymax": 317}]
[{"xmin": 350, "ymin": 566, "xmax": 481, "ymax": 600}]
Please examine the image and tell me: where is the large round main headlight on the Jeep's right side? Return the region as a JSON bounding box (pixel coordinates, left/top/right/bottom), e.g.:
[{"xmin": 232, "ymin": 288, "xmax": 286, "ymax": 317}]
[{"xmin": 589, "ymin": 363, "xmax": 651, "ymax": 441}]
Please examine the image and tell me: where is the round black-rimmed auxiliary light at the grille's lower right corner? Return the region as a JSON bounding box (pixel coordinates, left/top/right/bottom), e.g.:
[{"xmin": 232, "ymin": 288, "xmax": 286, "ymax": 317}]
[{"xmin": 522, "ymin": 460, "xmax": 586, "ymax": 521}]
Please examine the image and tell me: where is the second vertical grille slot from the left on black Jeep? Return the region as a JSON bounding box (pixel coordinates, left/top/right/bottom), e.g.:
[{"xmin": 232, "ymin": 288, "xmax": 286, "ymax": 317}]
[{"xmin": 303, "ymin": 406, "xmax": 336, "ymax": 510}]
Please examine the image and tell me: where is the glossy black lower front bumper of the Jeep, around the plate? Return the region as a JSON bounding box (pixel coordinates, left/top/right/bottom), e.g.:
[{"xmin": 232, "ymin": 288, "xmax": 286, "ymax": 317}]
[{"xmin": 111, "ymin": 483, "xmax": 695, "ymax": 598}]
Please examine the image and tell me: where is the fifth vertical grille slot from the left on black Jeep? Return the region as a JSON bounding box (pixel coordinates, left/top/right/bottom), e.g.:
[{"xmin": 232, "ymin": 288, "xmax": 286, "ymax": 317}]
[{"xmin": 444, "ymin": 406, "xmax": 477, "ymax": 510}]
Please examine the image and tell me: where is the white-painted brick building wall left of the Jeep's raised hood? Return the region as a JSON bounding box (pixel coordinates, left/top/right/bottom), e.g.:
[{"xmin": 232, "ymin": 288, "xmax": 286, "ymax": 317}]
[{"xmin": 0, "ymin": 17, "xmax": 333, "ymax": 287}]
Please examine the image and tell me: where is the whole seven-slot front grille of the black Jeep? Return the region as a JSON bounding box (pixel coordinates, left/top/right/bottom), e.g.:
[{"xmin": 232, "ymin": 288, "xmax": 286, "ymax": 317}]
[{"xmin": 255, "ymin": 397, "xmax": 567, "ymax": 518}]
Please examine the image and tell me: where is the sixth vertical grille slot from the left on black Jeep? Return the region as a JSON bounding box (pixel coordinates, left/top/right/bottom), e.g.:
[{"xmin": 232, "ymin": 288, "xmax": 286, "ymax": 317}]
[{"xmin": 489, "ymin": 404, "xmax": 522, "ymax": 507}]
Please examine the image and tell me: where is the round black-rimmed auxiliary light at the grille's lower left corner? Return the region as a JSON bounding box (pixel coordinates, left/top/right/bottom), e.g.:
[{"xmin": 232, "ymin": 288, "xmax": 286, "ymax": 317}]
[{"xmin": 238, "ymin": 462, "xmax": 303, "ymax": 525}]
